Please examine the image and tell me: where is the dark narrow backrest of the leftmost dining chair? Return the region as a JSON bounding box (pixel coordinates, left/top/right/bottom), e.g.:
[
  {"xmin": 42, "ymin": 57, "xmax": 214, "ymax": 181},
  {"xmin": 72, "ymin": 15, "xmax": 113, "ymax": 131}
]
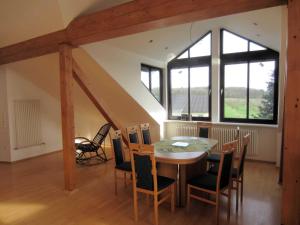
[{"xmin": 110, "ymin": 130, "xmax": 124, "ymax": 165}]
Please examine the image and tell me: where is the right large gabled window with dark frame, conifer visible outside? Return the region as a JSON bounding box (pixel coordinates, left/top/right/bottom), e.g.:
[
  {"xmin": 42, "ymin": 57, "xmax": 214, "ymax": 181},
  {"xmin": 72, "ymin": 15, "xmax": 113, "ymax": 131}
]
[{"xmin": 220, "ymin": 30, "xmax": 279, "ymax": 124}]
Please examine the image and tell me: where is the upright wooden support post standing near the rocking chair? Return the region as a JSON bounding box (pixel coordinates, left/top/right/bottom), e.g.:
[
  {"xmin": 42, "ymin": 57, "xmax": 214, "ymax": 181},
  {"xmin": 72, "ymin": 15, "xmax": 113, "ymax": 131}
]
[{"xmin": 59, "ymin": 44, "xmax": 75, "ymax": 191}]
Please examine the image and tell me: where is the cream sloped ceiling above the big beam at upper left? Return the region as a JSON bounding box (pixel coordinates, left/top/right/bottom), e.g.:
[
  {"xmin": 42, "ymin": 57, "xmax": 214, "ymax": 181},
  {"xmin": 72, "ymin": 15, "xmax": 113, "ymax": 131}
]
[{"xmin": 0, "ymin": 0, "xmax": 130, "ymax": 47}]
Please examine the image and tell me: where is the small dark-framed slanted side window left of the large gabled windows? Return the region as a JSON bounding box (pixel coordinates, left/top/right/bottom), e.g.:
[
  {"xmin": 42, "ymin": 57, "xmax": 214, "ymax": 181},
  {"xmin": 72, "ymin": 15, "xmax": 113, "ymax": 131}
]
[{"xmin": 141, "ymin": 64, "xmax": 163, "ymax": 104}]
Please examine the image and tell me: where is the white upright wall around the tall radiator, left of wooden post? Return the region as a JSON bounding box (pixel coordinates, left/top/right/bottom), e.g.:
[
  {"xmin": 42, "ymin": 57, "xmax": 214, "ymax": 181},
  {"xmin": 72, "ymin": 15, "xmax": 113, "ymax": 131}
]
[{"xmin": 7, "ymin": 67, "xmax": 62, "ymax": 161}]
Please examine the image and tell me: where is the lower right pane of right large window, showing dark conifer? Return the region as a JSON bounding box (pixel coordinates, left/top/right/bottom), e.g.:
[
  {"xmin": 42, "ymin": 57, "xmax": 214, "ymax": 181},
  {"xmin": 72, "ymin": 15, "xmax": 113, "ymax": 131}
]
[{"xmin": 249, "ymin": 61, "xmax": 275, "ymax": 120}]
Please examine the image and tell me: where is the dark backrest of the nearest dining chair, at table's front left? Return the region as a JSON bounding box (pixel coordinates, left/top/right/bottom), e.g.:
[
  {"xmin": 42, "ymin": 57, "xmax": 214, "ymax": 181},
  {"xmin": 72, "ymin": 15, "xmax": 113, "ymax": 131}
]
[{"xmin": 129, "ymin": 143, "xmax": 157, "ymax": 191}]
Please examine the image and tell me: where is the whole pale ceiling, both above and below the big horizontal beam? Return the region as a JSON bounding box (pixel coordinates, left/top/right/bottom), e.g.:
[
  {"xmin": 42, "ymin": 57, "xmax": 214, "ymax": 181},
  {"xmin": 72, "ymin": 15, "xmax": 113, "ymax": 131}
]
[{"xmin": 0, "ymin": 0, "xmax": 286, "ymax": 62}]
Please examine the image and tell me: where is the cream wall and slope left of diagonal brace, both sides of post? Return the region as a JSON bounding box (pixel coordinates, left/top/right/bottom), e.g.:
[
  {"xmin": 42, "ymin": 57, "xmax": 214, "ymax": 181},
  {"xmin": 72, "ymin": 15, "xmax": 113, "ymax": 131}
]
[{"xmin": 0, "ymin": 54, "xmax": 109, "ymax": 161}]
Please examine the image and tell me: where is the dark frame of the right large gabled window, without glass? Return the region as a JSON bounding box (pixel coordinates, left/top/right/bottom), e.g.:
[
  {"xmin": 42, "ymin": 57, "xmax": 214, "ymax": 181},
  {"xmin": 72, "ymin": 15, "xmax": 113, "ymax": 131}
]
[{"xmin": 219, "ymin": 29, "xmax": 279, "ymax": 125}]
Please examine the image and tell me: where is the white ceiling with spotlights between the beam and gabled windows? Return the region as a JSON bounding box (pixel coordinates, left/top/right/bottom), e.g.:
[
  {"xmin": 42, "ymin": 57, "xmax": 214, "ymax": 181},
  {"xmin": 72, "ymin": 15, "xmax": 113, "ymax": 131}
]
[{"xmin": 101, "ymin": 6, "xmax": 285, "ymax": 62}]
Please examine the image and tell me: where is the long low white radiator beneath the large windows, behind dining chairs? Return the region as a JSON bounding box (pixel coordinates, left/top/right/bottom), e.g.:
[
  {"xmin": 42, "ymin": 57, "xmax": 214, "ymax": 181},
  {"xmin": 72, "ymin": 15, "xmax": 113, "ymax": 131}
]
[{"xmin": 176, "ymin": 124, "xmax": 260, "ymax": 156}]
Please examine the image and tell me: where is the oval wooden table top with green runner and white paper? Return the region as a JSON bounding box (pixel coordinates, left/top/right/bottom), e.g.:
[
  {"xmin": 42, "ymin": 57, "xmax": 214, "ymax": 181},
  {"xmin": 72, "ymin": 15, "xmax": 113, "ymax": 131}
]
[{"xmin": 154, "ymin": 136, "xmax": 218, "ymax": 165}]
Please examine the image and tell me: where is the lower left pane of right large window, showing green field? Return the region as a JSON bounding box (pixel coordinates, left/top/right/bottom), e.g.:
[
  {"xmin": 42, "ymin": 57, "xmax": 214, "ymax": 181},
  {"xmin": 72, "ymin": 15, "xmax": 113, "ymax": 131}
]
[{"xmin": 224, "ymin": 63, "xmax": 247, "ymax": 118}]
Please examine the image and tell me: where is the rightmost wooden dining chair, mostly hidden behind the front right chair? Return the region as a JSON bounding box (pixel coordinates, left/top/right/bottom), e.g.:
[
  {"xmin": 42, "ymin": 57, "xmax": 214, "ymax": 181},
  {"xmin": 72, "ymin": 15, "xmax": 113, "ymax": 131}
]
[{"xmin": 232, "ymin": 134, "xmax": 250, "ymax": 211}]
